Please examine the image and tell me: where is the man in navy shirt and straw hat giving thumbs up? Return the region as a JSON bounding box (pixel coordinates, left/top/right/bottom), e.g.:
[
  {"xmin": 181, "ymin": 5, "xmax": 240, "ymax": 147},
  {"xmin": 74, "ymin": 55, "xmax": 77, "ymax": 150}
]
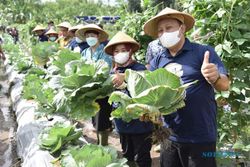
[{"xmin": 144, "ymin": 8, "xmax": 230, "ymax": 167}]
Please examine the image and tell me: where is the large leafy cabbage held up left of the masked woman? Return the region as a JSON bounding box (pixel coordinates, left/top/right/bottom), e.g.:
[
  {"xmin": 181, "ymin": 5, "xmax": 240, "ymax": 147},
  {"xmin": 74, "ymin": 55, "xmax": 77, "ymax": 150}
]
[{"xmin": 53, "ymin": 60, "xmax": 113, "ymax": 119}]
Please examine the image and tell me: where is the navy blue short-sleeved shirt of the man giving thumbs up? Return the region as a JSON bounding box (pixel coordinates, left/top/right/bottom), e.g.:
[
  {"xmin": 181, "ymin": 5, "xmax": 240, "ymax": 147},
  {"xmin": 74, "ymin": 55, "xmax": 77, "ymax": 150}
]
[{"xmin": 150, "ymin": 39, "xmax": 227, "ymax": 143}]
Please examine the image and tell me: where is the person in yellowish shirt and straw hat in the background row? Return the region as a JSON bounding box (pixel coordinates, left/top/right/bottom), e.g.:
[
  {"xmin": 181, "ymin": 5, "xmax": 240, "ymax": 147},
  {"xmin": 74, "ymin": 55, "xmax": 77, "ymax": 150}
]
[{"xmin": 57, "ymin": 22, "xmax": 71, "ymax": 48}]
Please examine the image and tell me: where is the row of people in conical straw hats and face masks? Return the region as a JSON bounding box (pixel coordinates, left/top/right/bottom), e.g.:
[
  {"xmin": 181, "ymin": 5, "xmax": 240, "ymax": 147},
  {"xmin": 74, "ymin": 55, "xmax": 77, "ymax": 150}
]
[{"xmin": 3, "ymin": 8, "xmax": 230, "ymax": 167}]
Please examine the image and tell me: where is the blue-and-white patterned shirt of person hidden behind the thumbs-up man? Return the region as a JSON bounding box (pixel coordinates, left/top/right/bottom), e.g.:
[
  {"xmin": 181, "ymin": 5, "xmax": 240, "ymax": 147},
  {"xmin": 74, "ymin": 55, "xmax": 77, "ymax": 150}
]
[{"xmin": 146, "ymin": 39, "xmax": 166, "ymax": 64}]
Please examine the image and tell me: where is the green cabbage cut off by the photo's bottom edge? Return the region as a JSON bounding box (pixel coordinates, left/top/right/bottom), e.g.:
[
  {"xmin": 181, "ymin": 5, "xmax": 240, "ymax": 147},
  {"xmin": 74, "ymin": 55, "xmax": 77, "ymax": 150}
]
[{"xmin": 60, "ymin": 144, "xmax": 128, "ymax": 167}]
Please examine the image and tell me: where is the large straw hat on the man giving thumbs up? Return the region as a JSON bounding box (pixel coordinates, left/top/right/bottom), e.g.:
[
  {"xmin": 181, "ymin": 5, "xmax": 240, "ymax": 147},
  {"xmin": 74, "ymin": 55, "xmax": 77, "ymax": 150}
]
[{"xmin": 144, "ymin": 7, "xmax": 195, "ymax": 38}]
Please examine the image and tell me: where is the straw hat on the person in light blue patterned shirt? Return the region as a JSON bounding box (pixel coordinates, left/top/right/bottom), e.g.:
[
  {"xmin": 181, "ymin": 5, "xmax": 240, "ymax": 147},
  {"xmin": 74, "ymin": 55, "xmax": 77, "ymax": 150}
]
[{"xmin": 76, "ymin": 24, "xmax": 109, "ymax": 42}]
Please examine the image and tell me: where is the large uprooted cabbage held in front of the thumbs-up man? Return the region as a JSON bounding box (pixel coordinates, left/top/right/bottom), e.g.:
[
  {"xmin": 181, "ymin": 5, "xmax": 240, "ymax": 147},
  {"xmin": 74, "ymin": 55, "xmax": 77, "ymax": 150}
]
[{"xmin": 109, "ymin": 68, "xmax": 195, "ymax": 122}]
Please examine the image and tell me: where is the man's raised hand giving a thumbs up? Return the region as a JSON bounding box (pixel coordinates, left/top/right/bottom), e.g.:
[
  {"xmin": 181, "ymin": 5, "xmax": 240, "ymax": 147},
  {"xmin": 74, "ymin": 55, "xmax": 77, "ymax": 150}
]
[{"xmin": 201, "ymin": 51, "xmax": 220, "ymax": 84}]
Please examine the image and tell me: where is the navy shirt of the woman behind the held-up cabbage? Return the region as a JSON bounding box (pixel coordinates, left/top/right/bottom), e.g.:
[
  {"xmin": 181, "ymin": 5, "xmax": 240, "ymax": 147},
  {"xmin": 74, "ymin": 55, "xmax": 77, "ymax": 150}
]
[{"xmin": 113, "ymin": 62, "xmax": 153, "ymax": 134}]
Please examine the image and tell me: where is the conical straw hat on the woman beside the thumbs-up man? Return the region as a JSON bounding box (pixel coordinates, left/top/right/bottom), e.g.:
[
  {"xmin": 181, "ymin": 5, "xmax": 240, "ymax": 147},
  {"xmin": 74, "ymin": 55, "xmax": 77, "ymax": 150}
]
[{"xmin": 104, "ymin": 31, "xmax": 140, "ymax": 55}]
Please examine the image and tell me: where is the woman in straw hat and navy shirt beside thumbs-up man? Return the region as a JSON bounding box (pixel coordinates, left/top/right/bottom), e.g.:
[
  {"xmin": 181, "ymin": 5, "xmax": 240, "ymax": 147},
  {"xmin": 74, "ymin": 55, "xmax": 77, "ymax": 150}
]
[{"xmin": 105, "ymin": 32, "xmax": 153, "ymax": 167}]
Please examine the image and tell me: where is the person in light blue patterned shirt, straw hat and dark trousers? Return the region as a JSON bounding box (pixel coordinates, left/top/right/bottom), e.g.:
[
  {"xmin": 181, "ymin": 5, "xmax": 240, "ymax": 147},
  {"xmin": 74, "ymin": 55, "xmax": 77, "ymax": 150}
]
[{"xmin": 76, "ymin": 24, "xmax": 112, "ymax": 146}]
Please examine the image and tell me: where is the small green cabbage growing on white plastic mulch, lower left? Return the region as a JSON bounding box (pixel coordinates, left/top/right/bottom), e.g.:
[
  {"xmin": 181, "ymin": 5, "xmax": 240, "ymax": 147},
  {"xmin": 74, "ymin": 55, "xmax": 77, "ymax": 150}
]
[{"xmin": 40, "ymin": 123, "xmax": 82, "ymax": 154}]
